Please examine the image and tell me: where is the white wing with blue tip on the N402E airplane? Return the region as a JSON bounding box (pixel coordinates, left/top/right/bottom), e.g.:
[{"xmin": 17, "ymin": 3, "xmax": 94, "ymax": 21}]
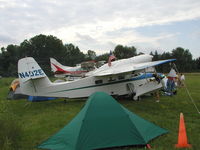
[{"xmin": 93, "ymin": 59, "xmax": 176, "ymax": 76}]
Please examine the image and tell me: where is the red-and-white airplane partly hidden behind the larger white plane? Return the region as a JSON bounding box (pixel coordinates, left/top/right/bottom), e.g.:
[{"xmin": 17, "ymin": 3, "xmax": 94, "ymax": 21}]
[{"xmin": 50, "ymin": 58, "xmax": 88, "ymax": 77}]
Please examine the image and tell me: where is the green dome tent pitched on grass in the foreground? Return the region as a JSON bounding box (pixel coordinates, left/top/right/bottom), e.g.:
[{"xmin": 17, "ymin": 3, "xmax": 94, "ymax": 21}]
[{"xmin": 38, "ymin": 92, "xmax": 168, "ymax": 150}]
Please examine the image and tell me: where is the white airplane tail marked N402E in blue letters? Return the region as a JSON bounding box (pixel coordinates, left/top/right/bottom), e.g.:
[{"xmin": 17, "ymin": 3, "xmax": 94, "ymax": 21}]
[{"xmin": 18, "ymin": 57, "xmax": 51, "ymax": 96}]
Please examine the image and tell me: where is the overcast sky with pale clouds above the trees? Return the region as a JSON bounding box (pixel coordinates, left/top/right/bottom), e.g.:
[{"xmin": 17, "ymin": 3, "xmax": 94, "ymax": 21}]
[{"xmin": 0, "ymin": 0, "xmax": 200, "ymax": 58}]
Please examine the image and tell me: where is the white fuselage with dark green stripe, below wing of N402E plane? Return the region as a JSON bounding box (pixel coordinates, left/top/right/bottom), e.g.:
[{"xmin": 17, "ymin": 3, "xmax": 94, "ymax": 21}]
[{"xmin": 19, "ymin": 74, "xmax": 162, "ymax": 99}]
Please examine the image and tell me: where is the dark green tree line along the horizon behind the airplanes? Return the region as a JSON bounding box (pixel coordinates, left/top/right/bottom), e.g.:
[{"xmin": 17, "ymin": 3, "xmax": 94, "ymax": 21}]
[{"xmin": 0, "ymin": 34, "xmax": 200, "ymax": 77}]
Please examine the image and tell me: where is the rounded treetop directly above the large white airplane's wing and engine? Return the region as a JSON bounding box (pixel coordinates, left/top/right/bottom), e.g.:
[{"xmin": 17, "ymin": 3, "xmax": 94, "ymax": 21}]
[{"xmin": 114, "ymin": 45, "xmax": 137, "ymax": 59}]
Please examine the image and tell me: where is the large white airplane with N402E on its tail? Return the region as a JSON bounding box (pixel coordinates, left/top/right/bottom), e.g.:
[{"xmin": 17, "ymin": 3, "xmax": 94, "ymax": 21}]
[{"xmin": 18, "ymin": 54, "xmax": 175, "ymax": 100}]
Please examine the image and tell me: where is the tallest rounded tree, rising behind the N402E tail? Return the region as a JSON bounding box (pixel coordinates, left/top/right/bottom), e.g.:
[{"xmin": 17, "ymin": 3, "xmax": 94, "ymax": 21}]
[{"xmin": 19, "ymin": 34, "xmax": 65, "ymax": 75}]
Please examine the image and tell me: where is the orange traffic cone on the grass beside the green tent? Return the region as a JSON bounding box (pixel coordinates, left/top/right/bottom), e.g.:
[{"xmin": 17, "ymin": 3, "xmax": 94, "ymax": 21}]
[{"xmin": 175, "ymin": 113, "xmax": 191, "ymax": 148}]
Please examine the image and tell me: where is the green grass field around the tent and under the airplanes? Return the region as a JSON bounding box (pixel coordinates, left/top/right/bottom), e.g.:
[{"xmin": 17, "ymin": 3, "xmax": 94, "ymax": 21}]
[{"xmin": 0, "ymin": 74, "xmax": 200, "ymax": 150}]
